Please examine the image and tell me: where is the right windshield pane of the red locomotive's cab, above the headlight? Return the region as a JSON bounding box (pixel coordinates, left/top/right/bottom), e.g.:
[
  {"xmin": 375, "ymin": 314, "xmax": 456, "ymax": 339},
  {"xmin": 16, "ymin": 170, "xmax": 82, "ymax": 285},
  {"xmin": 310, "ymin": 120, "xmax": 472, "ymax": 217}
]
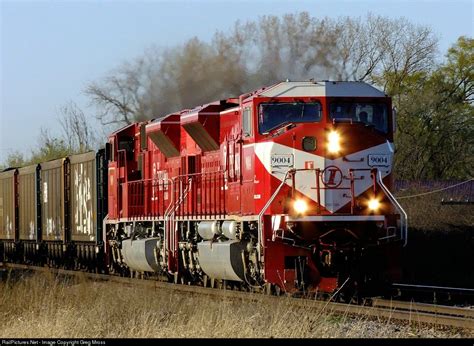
[{"xmin": 329, "ymin": 102, "xmax": 388, "ymax": 133}]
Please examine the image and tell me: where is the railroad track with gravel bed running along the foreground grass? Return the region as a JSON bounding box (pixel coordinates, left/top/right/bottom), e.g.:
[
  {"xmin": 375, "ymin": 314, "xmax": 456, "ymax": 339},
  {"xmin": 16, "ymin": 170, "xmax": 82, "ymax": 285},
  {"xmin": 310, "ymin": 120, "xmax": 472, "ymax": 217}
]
[{"xmin": 3, "ymin": 263, "xmax": 474, "ymax": 330}]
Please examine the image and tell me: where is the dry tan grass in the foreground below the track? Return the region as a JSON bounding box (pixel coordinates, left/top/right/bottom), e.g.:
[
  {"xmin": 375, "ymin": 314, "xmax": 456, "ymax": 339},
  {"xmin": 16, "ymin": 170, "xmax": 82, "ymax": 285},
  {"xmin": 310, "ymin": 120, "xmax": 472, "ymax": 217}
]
[{"xmin": 0, "ymin": 274, "xmax": 473, "ymax": 338}]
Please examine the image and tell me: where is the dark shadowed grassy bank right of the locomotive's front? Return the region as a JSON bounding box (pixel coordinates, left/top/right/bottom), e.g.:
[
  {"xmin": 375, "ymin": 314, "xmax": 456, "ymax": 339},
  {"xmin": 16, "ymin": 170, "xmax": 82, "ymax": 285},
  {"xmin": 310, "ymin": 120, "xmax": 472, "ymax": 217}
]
[{"xmin": 400, "ymin": 192, "xmax": 474, "ymax": 288}]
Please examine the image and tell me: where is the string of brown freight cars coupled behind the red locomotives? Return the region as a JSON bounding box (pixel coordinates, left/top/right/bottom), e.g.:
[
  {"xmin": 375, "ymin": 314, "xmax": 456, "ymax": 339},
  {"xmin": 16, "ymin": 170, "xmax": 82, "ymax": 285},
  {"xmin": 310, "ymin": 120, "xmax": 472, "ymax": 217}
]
[{"xmin": 0, "ymin": 150, "xmax": 107, "ymax": 271}]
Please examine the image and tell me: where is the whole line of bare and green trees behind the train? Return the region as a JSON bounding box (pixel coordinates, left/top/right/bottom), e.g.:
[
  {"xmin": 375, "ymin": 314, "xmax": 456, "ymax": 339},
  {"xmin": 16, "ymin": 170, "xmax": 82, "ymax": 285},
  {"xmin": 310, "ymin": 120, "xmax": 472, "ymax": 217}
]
[{"xmin": 1, "ymin": 12, "xmax": 474, "ymax": 180}]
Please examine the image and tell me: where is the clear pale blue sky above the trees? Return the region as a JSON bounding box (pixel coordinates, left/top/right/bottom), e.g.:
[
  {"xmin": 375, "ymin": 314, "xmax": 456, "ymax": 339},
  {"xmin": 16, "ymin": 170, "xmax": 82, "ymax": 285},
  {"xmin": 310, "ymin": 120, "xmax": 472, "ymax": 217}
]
[{"xmin": 0, "ymin": 0, "xmax": 474, "ymax": 163}]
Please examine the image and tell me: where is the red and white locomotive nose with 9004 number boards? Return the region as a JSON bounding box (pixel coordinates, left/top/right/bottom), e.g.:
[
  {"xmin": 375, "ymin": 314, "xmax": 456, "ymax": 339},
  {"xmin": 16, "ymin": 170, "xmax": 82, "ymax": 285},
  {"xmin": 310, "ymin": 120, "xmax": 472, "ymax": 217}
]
[{"xmin": 256, "ymin": 124, "xmax": 393, "ymax": 215}]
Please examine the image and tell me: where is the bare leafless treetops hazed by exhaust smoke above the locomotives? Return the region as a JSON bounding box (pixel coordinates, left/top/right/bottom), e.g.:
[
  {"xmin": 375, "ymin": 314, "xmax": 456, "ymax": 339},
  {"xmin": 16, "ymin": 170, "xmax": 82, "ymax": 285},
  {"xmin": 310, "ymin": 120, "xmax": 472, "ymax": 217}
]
[{"xmin": 85, "ymin": 12, "xmax": 437, "ymax": 127}]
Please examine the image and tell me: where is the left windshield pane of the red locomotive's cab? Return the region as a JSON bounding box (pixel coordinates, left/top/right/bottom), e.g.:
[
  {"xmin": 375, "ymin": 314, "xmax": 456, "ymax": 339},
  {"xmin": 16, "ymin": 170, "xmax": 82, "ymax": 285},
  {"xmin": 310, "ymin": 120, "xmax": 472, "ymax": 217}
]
[{"xmin": 258, "ymin": 102, "xmax": 321, "ymax": 134}]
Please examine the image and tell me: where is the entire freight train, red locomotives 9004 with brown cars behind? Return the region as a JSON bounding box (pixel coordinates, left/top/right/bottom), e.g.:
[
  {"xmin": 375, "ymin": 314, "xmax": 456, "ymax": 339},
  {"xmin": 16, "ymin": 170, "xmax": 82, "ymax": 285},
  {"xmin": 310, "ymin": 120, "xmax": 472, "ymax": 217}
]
[{"xmin": 0, "ymin": 81, "xmax": 407, "ymax": 296}]
